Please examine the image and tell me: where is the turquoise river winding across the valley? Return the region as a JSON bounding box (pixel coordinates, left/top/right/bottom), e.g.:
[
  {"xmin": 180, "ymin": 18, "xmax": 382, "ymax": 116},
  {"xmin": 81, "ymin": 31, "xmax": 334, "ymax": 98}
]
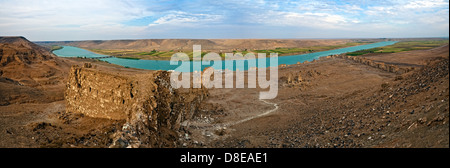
[{"xmin": 53, "ymin": 41, "xmax": 397, "ymax": 72}]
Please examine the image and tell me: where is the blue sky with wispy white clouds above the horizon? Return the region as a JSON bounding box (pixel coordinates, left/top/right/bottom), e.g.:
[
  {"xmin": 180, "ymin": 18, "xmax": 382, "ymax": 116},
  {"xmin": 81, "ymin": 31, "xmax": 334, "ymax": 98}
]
[{"xmin": 0, "ymin": 0, "xmax": 449, "ymax": 41}]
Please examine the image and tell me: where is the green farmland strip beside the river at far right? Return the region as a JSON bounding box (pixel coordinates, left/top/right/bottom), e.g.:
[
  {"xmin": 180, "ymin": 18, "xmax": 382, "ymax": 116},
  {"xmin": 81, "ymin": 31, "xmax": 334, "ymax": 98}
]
[{"xmin": 347, "ymin": 40, "xmax": 448, "ymax": 56}]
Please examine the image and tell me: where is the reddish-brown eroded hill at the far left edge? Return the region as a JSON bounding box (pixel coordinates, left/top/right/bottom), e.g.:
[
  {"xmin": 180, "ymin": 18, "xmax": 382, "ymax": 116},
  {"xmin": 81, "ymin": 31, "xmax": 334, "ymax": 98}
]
[{"xmin": 0, "ymin": 37, "xmax": 70, "ymax": 87}]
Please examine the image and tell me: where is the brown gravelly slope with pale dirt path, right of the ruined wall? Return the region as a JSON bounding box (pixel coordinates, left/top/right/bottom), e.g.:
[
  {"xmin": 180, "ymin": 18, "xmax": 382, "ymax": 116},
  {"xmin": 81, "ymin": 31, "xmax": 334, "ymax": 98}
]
[{"xmin": 184, "ymin": 45, "xmax": 449, "ymax": 148}]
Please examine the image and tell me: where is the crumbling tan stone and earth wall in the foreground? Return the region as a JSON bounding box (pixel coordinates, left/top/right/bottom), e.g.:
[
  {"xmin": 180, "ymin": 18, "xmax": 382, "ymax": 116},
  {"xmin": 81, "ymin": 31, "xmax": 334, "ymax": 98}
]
[{"xmin": 65, "ymin": 66, "xmax": 207, "ymax": 147}]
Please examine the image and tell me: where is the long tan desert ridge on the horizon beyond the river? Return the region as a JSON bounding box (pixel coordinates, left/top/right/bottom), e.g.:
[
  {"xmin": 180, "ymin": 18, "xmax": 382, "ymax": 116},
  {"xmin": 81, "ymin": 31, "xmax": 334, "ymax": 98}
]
[{"xmin": 37, "ymin": 39, "xmax": 380, "ymax": 52}]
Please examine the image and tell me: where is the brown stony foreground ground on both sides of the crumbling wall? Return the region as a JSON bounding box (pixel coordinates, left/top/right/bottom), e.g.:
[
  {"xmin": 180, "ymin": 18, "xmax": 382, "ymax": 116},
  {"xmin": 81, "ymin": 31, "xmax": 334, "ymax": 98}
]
[{"xmin": 0, "ymin": 46, "xmax": 449, "ymax": 148}]
